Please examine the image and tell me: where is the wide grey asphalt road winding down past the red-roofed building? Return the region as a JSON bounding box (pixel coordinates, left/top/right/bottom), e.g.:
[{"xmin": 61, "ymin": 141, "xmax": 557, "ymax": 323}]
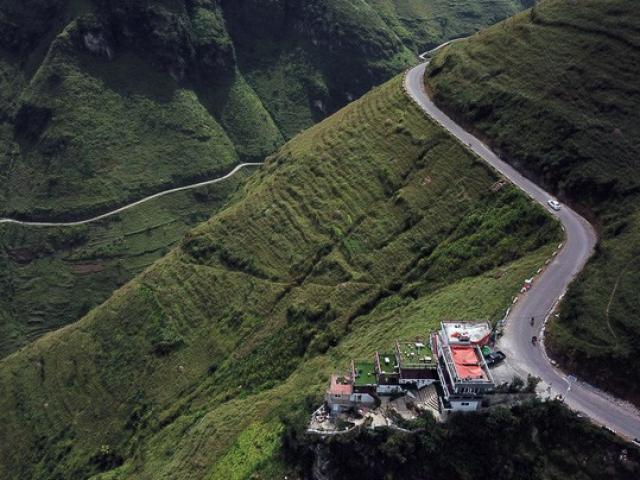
[{"xmin": 405, "ymin": 58, "xmax": 640, "ymax": 438}]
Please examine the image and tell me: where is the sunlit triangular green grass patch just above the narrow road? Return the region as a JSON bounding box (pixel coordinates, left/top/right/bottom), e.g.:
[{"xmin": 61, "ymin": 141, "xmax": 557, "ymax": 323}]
[{"xmin": 5, "ymin": 44, "xmax": 242, "ymax": 218}]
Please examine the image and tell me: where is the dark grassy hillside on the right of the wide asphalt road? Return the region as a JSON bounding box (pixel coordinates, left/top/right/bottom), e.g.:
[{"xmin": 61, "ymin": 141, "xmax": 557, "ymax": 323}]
[{"xmin": 427, "ymin": 0, "xmax": 640, "ymax": 402}]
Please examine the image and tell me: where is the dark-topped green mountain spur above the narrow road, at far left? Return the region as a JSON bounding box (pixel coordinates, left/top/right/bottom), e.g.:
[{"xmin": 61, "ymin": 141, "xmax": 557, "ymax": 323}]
[{"xmin": 0, "ymin": 0, "xmax": 283, "ymax": 219}]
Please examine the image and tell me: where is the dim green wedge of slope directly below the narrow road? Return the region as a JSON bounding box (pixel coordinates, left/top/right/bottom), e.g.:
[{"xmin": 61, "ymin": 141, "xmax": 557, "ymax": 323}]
[{"xmin": 0, "ymin": 168, "xmax": 252, "ymax": 357}]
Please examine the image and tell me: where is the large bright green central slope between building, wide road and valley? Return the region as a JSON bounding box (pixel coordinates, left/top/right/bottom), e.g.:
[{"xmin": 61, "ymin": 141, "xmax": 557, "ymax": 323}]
[{"xmin": 0, "ymin": 78, "xmax": 559, "ymax": 479}]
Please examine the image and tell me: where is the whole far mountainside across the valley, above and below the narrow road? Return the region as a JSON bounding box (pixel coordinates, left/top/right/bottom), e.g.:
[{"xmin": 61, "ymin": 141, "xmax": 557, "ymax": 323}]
[{"xmin": 0, "ymin": 0, "xmax": 532, "ymax": 356}]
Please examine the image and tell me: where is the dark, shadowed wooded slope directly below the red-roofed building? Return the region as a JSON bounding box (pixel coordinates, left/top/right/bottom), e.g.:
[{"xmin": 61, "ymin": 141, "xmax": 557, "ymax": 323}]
[{"xmin": 289, "ymin": 402, "xmax": 640, "ymax": 480}]
